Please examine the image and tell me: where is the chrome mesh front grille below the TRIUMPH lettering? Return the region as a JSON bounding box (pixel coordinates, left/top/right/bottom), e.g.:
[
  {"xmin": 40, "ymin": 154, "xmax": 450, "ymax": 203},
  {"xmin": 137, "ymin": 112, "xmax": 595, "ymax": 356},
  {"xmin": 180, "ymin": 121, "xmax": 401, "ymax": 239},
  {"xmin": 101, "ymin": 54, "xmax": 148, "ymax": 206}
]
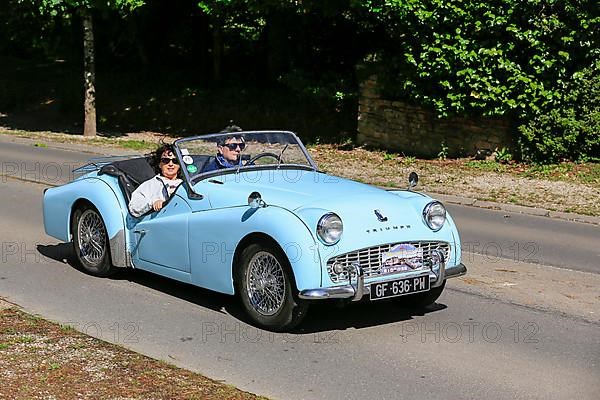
[{"xmin": 327, "ymin": 242, "xmax": 450, "ymax": 283}]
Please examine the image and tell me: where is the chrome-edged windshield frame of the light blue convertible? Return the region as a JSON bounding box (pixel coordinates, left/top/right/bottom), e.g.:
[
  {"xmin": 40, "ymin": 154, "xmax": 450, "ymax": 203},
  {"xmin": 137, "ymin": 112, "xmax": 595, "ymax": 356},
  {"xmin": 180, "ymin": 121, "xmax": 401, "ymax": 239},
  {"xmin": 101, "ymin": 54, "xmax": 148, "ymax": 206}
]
[{"xmin": 173, "ymin": 130, "xmax": 318, "ymax": 187}]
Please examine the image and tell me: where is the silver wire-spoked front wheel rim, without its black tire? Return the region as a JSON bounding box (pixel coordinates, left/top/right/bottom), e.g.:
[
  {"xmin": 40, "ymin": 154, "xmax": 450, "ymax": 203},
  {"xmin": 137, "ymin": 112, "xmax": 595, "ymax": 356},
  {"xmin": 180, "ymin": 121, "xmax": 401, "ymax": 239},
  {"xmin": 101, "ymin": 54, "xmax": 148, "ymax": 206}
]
[{"xmin": 246, "ymin": 251, "xmax": 285, "ymax": 316}]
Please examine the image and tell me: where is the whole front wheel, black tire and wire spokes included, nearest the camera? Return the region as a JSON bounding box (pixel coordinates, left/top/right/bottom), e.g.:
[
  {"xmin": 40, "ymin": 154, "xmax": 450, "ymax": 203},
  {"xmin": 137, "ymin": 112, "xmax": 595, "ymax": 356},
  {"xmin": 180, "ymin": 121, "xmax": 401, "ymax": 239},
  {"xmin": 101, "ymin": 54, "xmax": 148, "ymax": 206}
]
[{"xmin": 236, "ymin": 244, "xmax": 308, "ymax": 332}]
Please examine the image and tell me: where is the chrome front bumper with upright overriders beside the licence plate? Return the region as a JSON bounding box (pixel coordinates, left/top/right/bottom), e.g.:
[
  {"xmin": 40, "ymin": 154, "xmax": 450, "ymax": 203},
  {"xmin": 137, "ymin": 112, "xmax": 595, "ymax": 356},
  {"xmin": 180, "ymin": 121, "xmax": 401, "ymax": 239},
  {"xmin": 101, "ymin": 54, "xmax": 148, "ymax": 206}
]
[{"xmin": 299, "ymin": 261, "xmax": 467, "ymax": 301}]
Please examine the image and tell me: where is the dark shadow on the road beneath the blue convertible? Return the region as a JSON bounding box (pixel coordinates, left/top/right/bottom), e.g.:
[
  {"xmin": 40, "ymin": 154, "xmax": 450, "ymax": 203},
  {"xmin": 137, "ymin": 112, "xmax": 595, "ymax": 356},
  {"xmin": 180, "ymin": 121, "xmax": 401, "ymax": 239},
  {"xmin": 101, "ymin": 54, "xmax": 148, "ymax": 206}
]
[{"xmin": 37, "ymin": 243, "xmax": 446, "ymax": 335}]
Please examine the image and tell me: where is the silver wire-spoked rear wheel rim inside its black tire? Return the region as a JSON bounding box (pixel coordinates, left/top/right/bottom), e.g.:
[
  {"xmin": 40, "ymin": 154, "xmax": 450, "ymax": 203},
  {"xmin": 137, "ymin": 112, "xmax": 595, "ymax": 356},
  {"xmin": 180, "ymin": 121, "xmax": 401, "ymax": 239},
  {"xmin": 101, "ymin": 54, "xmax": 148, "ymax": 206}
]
[{"xmin": 77, "ymin": 210, "xmax": 106, "ymax": 266}]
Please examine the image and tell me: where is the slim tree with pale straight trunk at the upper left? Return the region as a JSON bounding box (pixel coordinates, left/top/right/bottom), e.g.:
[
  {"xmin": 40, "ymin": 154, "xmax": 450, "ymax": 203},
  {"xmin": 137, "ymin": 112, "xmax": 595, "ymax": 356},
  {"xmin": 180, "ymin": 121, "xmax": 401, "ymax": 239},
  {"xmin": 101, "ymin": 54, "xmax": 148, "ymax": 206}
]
[{"xmin": 29, "ymin": 0, "xmax": 145, "ymax": 136}]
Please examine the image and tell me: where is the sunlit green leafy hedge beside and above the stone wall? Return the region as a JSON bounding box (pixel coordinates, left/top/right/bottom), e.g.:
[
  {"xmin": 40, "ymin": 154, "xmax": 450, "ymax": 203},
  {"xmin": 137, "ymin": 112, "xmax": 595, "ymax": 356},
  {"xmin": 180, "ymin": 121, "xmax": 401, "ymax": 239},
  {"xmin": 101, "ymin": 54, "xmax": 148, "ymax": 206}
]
[{"xmin": 361, "ymin": 0, "xmax": 600, "ymax": 162}]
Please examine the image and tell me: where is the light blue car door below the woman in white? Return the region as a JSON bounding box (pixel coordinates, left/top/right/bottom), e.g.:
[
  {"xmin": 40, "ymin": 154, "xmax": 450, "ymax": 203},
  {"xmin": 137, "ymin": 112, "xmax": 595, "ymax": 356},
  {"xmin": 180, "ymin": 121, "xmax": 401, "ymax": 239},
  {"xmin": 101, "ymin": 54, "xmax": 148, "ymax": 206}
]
[{"xmin": 132, "ymin": 185, "xmax": 191, "ymax": 273}]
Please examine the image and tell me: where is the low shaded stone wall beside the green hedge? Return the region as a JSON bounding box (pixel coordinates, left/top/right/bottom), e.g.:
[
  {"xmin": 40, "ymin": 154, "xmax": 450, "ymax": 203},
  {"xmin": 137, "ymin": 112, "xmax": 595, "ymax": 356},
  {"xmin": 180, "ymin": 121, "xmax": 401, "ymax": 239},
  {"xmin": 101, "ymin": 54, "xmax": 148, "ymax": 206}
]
[{"xmin": 357, "ymin": 76, "xmax": 512, "ymax": 157}]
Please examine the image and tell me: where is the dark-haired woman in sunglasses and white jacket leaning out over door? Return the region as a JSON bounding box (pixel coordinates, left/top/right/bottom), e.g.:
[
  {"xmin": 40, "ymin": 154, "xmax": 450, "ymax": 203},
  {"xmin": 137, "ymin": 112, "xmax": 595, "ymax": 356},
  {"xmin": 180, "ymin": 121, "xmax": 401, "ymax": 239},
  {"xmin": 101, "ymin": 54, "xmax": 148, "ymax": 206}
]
[{"xmin": 129, "ymin": 144, "xmax": 182, "ymax": 217}]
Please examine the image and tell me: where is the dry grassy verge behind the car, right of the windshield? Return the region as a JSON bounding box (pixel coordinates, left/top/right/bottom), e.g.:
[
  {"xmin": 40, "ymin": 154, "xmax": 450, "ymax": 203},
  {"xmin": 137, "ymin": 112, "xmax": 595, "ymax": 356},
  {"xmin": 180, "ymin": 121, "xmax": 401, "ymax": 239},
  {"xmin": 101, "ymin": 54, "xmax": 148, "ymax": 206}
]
[{"xmin": 309, "ymin": 145, "xmax": 600, "ymax": 216}]
